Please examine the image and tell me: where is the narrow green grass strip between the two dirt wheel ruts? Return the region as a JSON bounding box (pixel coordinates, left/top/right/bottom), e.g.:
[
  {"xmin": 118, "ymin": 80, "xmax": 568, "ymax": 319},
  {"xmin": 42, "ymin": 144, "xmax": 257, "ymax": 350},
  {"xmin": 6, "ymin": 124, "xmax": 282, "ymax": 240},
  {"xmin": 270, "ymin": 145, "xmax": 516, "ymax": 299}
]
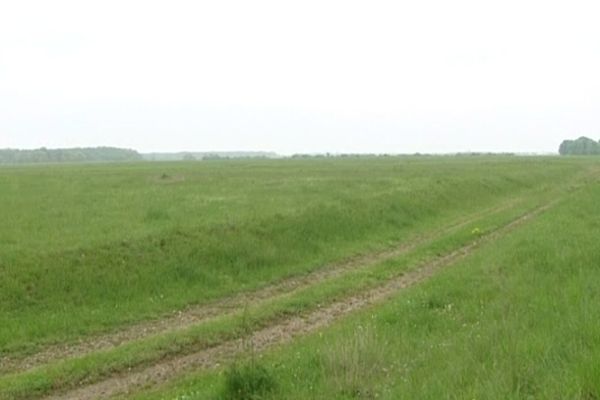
[{"xmin": 0, "ymin": 194, "xmax": 548, "ymax": 399}]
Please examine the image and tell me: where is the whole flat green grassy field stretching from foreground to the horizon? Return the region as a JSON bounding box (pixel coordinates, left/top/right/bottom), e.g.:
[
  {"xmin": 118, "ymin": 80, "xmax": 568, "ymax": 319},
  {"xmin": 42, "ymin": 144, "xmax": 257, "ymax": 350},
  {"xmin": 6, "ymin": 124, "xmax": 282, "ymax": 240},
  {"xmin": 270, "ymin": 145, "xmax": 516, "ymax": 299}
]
[{"xmin": 0, "ymin": 157, "xmax": 600, "ymax": 399}]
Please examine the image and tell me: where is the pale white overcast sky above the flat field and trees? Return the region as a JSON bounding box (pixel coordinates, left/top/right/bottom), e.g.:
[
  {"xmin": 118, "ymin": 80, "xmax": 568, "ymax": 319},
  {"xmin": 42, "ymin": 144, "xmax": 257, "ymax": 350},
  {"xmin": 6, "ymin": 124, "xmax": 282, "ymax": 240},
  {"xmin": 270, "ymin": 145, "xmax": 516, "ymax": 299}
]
[{"xmin": 0, "ymin": 0, "xmax": 600, "ymax": 154}]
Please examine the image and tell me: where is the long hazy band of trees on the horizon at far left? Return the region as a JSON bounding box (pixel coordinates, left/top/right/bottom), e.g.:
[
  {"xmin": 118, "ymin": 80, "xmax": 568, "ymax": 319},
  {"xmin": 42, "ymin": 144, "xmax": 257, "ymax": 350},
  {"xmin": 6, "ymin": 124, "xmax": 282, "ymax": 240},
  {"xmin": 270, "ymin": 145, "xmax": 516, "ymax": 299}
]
[{"xmin": 0, "ymin": 147, "xmax": 142, "ymax": 164}]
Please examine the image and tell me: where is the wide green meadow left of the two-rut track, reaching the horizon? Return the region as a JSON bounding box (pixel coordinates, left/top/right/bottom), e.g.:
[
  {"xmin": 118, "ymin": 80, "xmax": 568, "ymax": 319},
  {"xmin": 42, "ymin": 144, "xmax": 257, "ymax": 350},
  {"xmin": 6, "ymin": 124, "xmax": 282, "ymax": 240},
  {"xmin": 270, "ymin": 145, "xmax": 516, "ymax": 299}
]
[{"xmin": 0, "ymin": 157, "xmax": 589, "ymax": 355}]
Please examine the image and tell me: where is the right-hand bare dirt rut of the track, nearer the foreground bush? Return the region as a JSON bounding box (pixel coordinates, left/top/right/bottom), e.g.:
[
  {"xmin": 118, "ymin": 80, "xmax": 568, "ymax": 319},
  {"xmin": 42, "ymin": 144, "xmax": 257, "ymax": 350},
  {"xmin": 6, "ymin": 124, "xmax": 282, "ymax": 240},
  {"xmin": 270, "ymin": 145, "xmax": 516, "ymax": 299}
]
[{"xmin": 49, "ymin": 202, "xmax": 554, "ymax": 400}]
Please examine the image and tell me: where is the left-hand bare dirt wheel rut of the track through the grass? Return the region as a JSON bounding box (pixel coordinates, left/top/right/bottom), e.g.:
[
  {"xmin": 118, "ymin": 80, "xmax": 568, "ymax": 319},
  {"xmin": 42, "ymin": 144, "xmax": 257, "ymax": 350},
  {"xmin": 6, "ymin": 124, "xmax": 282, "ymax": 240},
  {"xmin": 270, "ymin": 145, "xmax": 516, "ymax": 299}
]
[{"xmin": 0, "ymin": 199, "xmax": 520, "ymax": 373}]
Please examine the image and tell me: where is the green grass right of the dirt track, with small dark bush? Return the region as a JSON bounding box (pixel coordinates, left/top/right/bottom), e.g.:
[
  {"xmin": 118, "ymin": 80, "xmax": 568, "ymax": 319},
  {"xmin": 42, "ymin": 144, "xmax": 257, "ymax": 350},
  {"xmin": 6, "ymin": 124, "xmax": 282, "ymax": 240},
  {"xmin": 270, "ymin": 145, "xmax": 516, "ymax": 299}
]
[{"xmin": 128, "ymin": 163, "xmax": 600, "ymax": 400}]
